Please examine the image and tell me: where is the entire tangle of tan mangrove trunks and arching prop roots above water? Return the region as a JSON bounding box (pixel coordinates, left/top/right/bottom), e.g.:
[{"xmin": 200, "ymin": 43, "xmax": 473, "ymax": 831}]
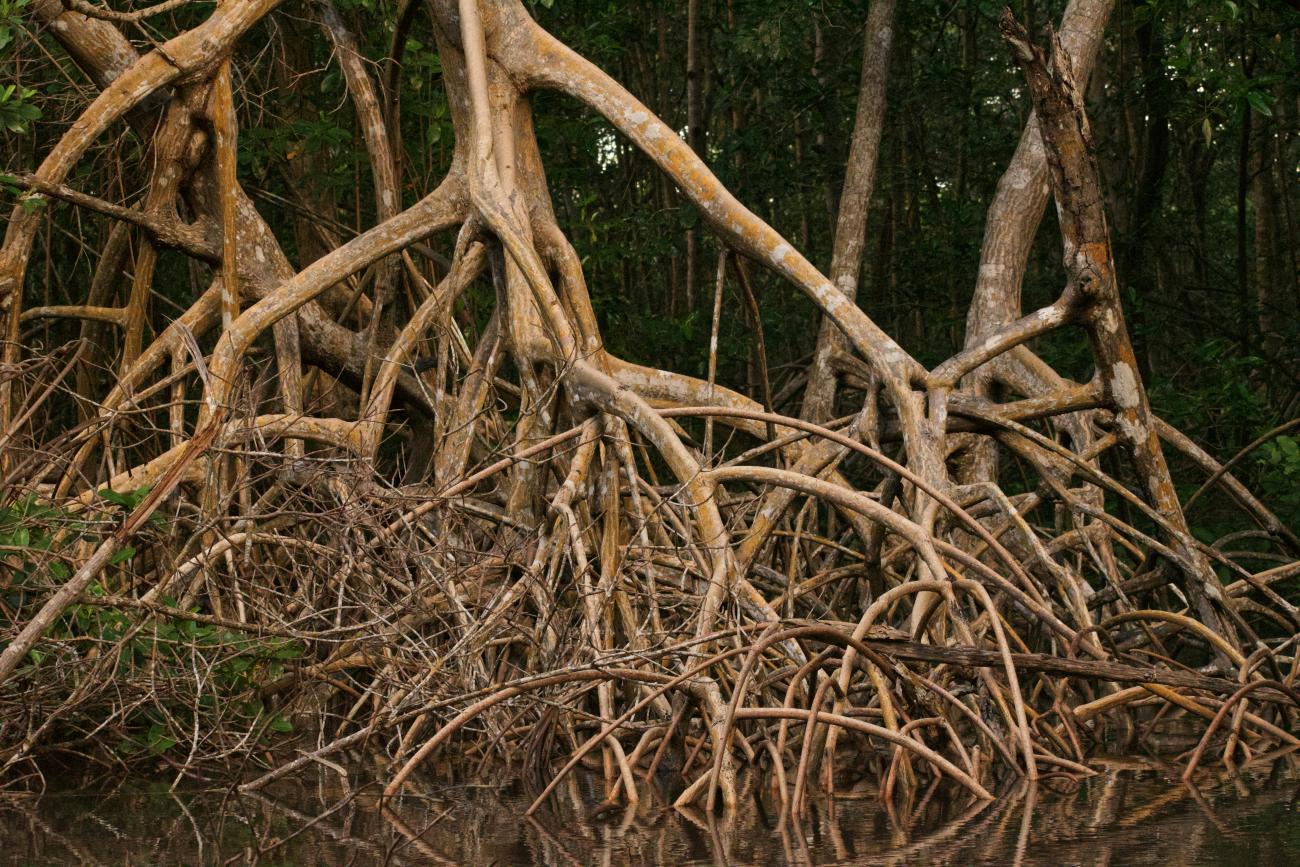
[{"xmin": 0, "ymin": 0, "xmax": 1300, "ymax": 812}]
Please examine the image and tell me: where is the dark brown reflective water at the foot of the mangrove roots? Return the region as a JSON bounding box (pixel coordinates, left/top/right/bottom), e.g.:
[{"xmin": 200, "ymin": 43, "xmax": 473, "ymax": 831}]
[{"xmin": 0, "ymin": 757, "xmax": 1300, "ymax": 867}]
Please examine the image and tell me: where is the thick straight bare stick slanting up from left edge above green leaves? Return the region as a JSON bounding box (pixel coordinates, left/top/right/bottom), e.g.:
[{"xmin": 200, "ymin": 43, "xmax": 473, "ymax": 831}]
[{"xmin": 0, "ymin": 409, "xmax": 224, "ymax": 685}]
